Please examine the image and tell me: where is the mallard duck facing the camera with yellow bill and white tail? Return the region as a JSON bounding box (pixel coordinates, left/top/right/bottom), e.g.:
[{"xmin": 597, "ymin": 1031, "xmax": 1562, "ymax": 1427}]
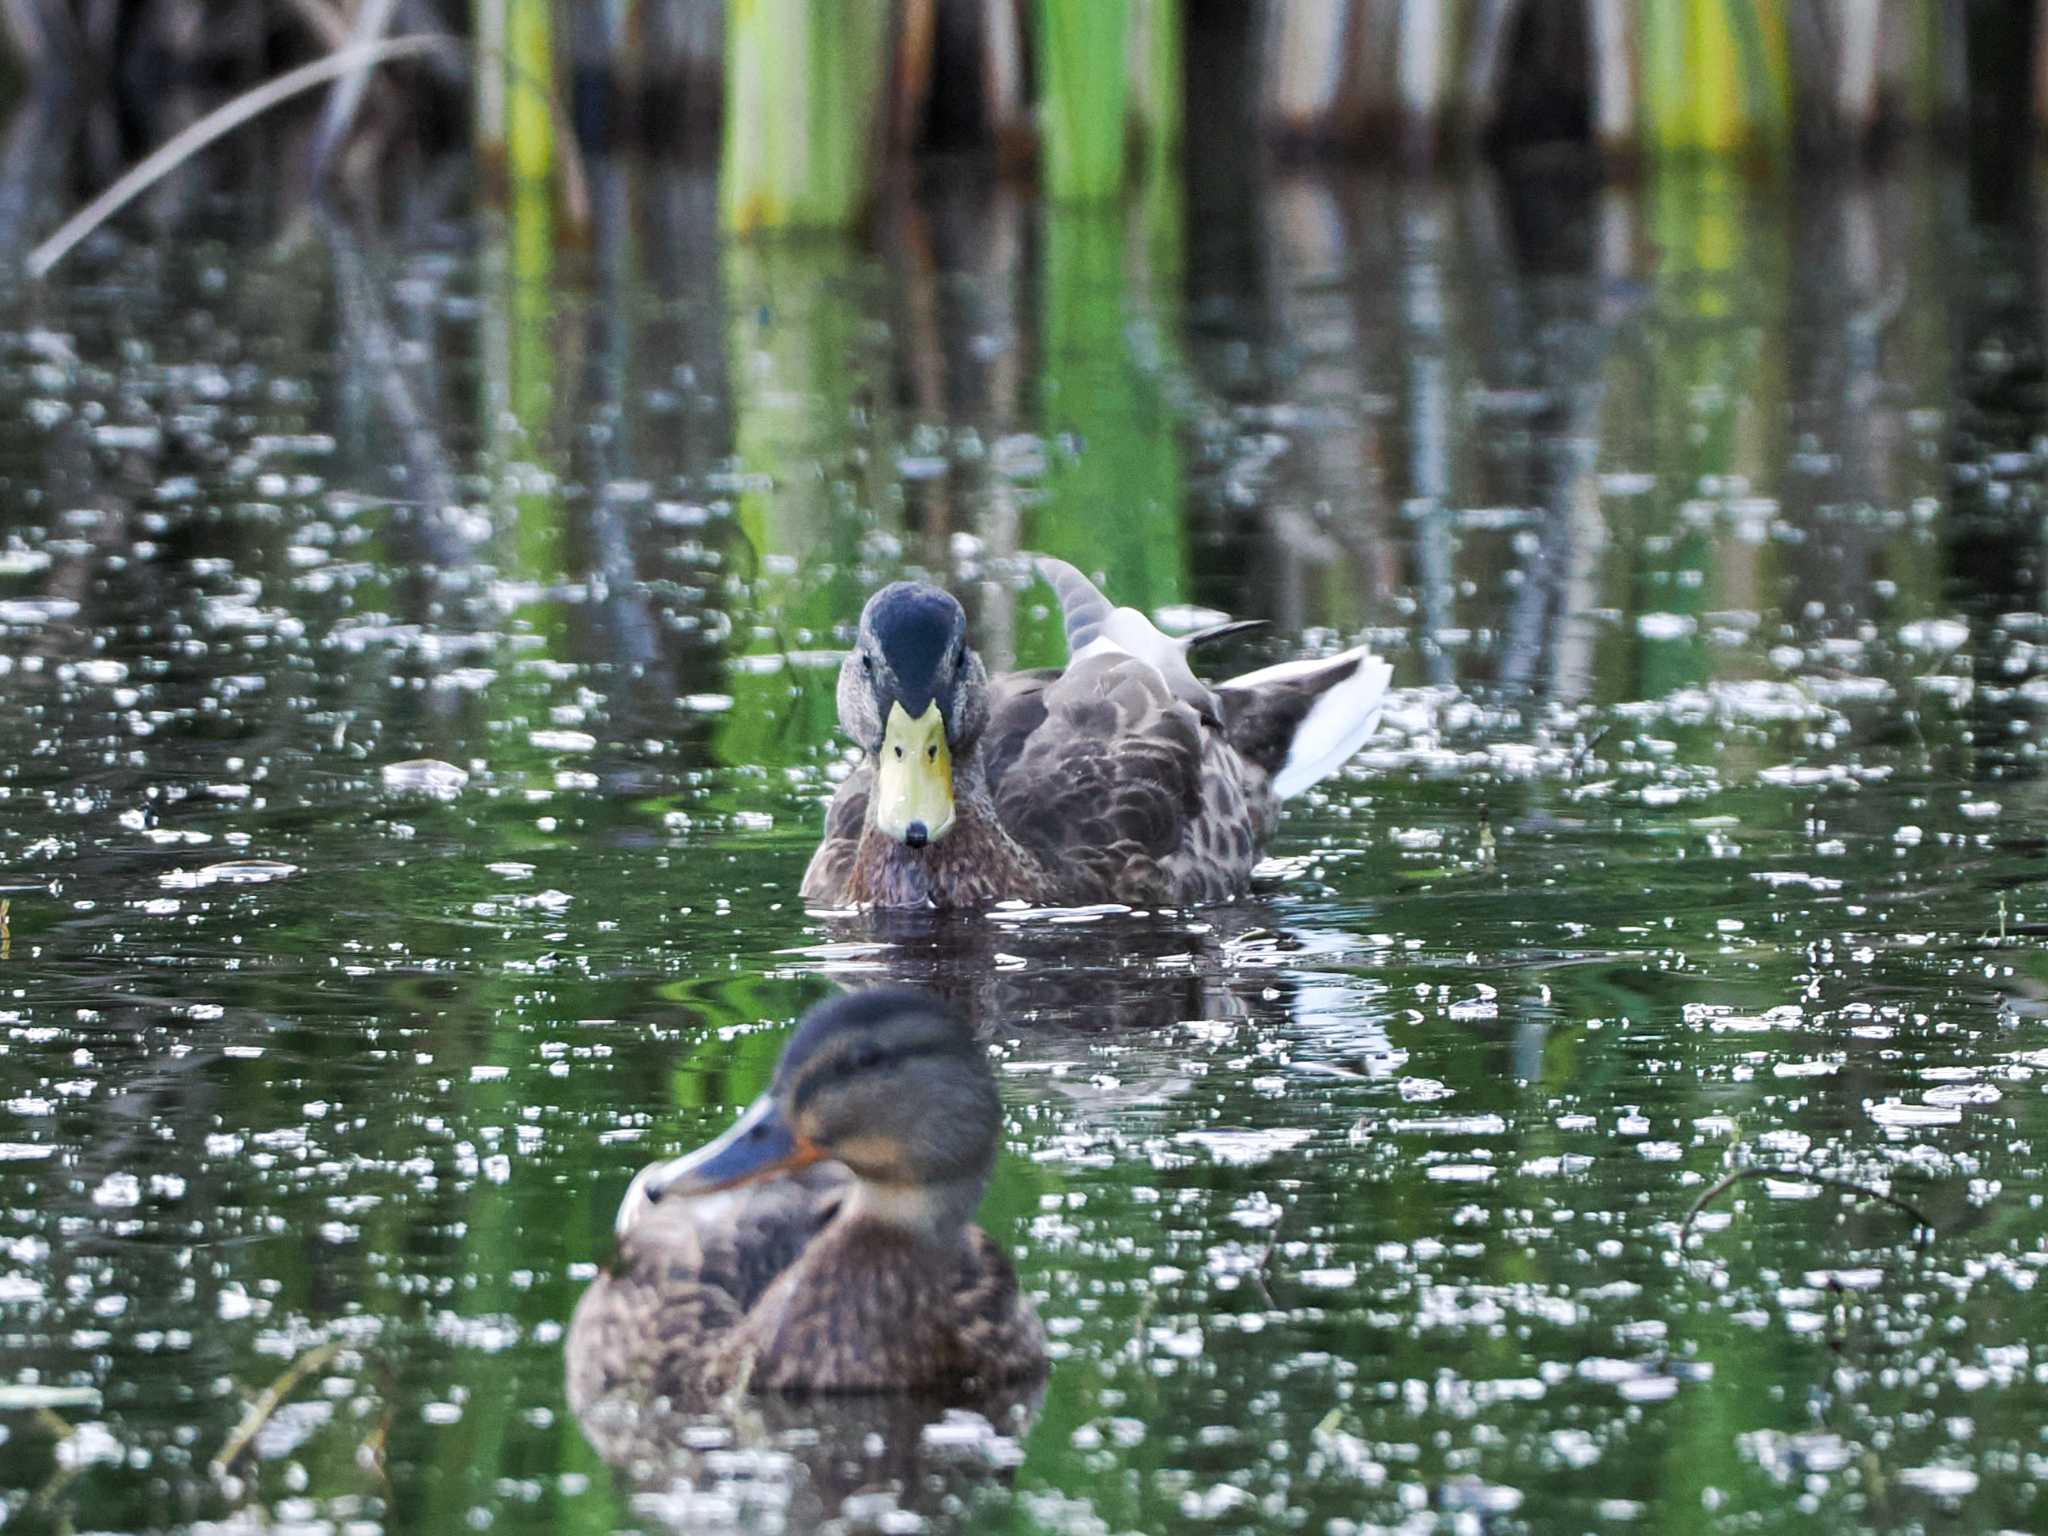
[{"xmin": 803, "ymin": 559, "xmax": 1393, "ymax": 907}]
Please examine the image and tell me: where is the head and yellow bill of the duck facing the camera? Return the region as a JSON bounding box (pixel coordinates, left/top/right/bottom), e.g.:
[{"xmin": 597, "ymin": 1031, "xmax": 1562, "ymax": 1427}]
[{"xmin": 840, "ymin": 582, "xmax": 989, "ymax": 848}]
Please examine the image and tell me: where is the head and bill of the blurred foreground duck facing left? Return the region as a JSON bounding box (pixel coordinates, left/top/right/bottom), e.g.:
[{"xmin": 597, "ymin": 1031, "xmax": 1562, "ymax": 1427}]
[{"xmin": 618, "ymin": 987, "xmax": 1001, "ymax": 1231}]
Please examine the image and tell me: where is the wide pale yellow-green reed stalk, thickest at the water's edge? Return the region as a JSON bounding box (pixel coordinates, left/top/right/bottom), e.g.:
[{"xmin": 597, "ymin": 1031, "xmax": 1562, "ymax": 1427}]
[{"xmin": 719, "ymin": 0, "xmax": 891, "ymax": 233}]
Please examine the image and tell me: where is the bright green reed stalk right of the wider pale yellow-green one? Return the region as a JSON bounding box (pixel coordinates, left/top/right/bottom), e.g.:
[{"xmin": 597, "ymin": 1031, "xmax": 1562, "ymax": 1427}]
[{"xmin": 1038, "ymin": 0, "xmax": 1130, "ymax": 203}]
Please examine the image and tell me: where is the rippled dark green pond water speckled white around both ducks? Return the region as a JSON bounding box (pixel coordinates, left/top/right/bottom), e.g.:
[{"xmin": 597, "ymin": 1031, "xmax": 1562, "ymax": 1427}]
[{"xmin": 0, "ymin": 147, "xmax": 2048, "ymax": 1536}]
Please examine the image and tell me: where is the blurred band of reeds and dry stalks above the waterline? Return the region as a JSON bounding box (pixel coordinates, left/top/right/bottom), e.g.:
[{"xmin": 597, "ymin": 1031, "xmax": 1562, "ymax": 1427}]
[{"xmin": 0, "ymin": 0, "xmax": 2048, "ymax": 246}]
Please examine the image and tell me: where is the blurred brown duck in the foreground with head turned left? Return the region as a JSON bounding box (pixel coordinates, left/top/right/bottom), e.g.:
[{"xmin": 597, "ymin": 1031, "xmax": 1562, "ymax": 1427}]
[{"xmin": 567, "ymin": 987, "xmax": 1047, "ymax": 1413}]
